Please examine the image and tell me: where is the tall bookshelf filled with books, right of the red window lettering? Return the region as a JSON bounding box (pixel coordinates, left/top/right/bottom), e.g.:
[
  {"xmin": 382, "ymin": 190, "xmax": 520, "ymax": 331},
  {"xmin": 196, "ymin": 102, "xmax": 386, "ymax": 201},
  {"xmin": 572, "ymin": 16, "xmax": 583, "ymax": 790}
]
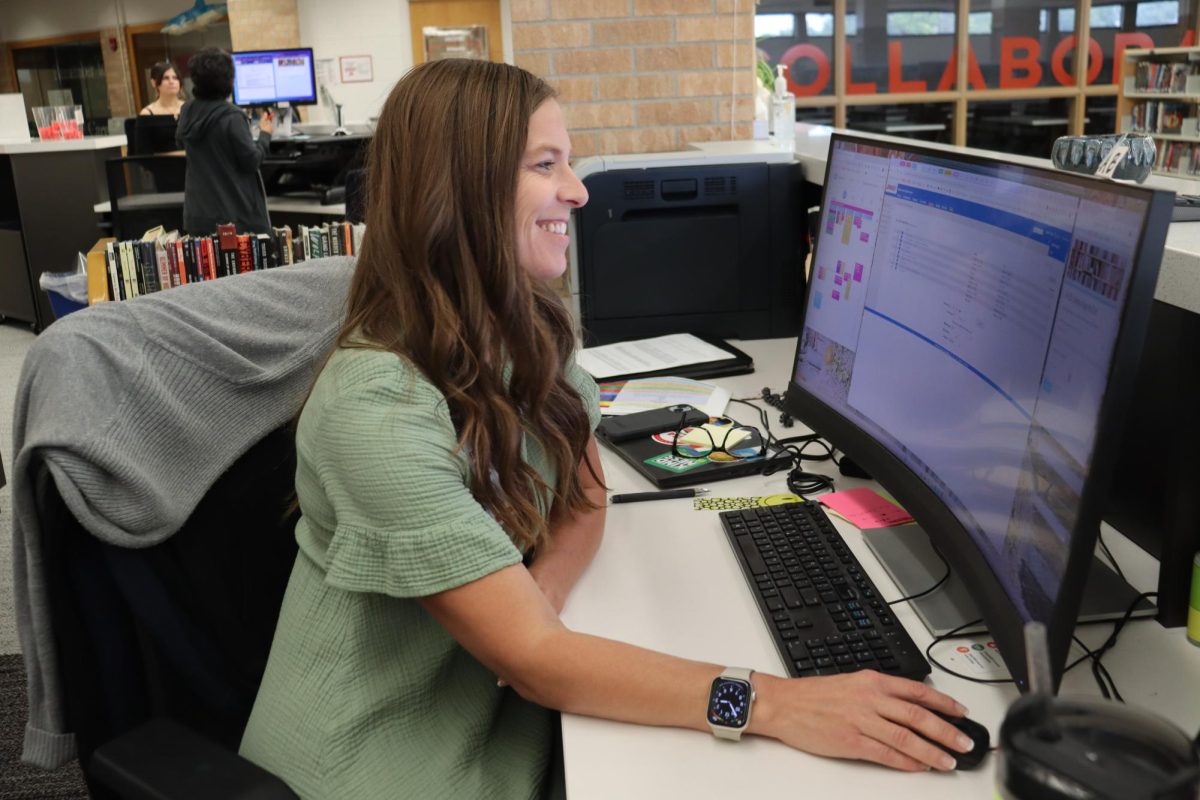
[{"xmin": 1117, "ymin": 47, "xmax": 1200, "ymax": 181}]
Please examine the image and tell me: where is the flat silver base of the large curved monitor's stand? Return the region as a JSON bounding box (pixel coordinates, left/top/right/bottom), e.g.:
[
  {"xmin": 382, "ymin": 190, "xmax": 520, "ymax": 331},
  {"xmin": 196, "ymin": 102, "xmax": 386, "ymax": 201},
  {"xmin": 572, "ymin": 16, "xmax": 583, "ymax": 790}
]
[{"xmin": 863, "ymin": 525, "xmax": 1158, "ymax": 637}]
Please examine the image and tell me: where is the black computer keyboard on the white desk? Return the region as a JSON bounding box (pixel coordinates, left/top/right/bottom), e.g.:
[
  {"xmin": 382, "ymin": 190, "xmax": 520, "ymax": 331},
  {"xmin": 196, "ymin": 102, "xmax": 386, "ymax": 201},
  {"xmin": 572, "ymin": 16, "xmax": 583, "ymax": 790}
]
[{"xmin": 721, "ymin": 500, "xmax": 930, "ymax": 680}]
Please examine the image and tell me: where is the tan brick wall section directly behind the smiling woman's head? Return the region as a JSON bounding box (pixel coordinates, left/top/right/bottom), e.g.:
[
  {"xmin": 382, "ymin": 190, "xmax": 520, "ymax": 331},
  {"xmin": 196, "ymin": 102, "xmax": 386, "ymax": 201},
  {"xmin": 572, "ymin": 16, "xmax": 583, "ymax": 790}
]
[{"xmin": 510, "ymin": 0, "xmax": 755, "ymax": 156}]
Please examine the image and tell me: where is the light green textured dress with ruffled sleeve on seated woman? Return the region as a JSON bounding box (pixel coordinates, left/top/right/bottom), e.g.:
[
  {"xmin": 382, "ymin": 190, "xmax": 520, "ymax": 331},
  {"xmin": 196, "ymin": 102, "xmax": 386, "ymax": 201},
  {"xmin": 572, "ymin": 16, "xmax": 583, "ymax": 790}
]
[{"xmin": 241, "ymin": 349, "xmax": 600, "ymax": 800}]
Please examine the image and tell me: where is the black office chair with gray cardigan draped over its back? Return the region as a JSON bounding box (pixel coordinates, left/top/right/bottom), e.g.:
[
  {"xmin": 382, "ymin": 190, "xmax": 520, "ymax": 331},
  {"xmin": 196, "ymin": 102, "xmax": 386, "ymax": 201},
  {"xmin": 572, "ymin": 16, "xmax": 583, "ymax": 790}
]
[{"xmin": 36, "ymin": 428, "xmax": 298, "ymax": 800}]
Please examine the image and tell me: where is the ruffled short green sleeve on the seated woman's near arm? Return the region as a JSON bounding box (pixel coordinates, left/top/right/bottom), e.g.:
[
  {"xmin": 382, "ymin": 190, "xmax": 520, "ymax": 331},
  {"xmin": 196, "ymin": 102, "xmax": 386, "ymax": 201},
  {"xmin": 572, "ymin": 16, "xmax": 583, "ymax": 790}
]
[{"xmin": 301, "ymin": 350, "xmax": 521, "ymax": 597}]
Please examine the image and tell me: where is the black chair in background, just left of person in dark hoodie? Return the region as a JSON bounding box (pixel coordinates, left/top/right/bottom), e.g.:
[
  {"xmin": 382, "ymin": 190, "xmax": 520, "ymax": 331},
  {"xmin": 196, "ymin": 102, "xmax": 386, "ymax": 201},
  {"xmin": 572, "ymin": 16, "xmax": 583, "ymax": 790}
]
[{"xmin": 104, "ymin": 155, "xmax": 187, "ymax": 240}]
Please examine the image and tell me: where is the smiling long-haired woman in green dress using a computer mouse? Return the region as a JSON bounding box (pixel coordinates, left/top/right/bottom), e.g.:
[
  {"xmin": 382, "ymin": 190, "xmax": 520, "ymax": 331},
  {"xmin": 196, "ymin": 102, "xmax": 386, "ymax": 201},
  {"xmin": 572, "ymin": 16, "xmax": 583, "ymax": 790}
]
[{"xmin": 236, "ymin": 59, "xmax": 971, "ymax": 800}]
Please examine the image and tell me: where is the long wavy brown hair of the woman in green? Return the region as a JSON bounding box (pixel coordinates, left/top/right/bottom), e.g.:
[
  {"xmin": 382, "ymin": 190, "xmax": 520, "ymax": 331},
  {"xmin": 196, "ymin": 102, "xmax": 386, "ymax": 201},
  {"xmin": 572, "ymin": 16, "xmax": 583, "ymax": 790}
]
[{"xmin": 338, "ymin": 59, "xmax": 595, "ymax": 549}]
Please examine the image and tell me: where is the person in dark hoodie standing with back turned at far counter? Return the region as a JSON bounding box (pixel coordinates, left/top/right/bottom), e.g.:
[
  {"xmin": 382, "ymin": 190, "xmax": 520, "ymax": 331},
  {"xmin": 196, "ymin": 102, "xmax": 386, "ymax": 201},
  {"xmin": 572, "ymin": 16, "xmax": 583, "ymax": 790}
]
[{"xmin": 175, "ymin": 47, "xmax": 275, "ymax": 235}]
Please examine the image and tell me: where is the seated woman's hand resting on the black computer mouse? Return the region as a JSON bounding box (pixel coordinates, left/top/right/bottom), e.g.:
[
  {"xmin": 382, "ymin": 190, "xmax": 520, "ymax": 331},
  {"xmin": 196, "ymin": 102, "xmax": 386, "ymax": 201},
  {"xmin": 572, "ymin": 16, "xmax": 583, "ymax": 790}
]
[{"xmin": 750, "ymin": 670, "xmax": 972, "ymax": 771}]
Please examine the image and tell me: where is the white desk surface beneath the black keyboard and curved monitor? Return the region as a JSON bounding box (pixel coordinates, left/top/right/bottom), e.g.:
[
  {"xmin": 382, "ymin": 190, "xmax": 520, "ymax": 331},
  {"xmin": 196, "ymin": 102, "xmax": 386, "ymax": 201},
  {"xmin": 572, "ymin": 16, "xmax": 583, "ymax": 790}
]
[{"xmin": 563, "ymin": 339, "xmax": 1200, "ymax": 800}]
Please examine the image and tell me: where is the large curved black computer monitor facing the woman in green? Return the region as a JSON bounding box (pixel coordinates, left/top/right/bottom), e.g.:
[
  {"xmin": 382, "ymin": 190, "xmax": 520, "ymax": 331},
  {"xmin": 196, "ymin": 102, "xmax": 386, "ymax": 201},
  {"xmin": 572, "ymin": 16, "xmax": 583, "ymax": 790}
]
[{"xmin": 786, "ymin": 134, "xmax": 1172, "ymax": 688}]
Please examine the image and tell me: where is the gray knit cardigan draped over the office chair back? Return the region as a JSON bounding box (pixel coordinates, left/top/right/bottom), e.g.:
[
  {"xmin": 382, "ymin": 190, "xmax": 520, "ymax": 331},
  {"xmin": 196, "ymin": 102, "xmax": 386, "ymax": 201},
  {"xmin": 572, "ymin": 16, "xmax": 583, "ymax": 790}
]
[{"xmin": 12, "ymin": 257, "xmax": 354, "ymax": 769}]
